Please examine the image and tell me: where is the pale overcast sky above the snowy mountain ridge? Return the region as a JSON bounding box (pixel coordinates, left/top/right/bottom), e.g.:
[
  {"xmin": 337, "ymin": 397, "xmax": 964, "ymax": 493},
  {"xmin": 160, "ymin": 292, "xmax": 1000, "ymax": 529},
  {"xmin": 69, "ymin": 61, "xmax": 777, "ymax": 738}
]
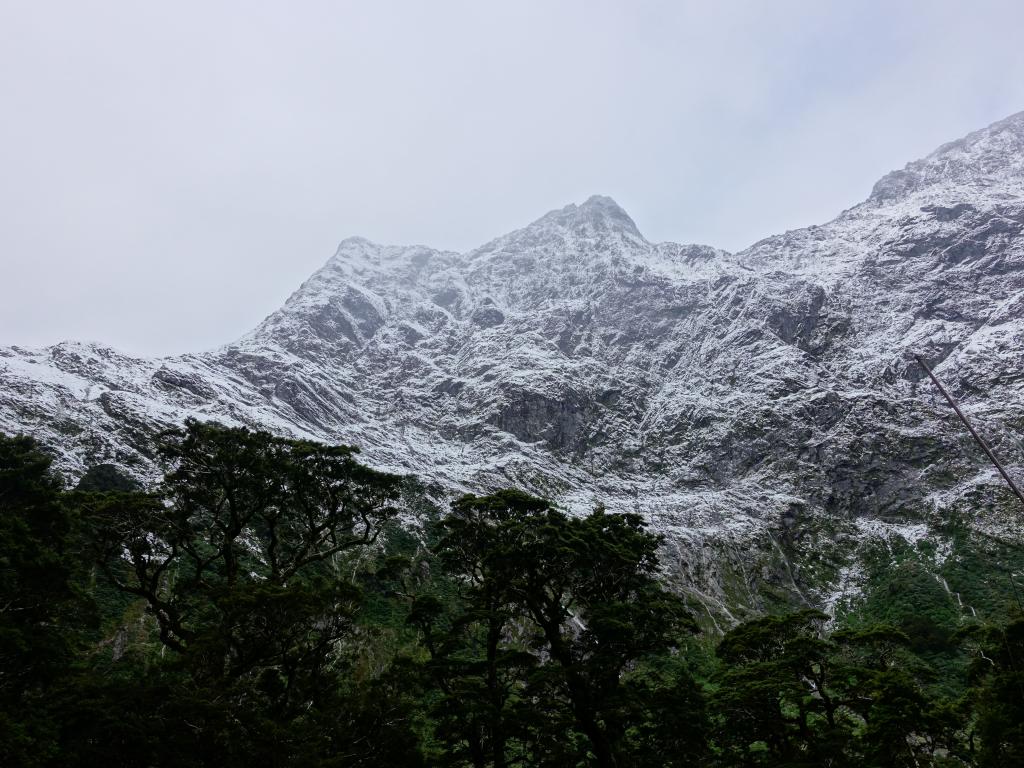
[{"xmin": 0, "ymin": 0, "xmax": 1024, "ymax": 353}]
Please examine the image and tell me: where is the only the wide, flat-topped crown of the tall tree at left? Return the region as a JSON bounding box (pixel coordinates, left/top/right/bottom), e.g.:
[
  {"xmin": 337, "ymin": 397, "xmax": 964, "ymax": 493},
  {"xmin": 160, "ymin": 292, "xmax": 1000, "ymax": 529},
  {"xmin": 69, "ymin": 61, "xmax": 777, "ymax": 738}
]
[{"xmin": 90, "ymin": 421, "xmax": 400, "ymax": 666}]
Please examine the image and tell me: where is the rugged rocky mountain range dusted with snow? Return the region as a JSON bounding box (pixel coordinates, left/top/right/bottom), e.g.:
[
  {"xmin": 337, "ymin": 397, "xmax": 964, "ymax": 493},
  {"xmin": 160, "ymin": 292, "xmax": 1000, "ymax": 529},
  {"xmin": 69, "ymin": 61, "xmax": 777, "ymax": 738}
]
[{"xmin": 0, "ymin": 113, "xmax": 1024, "ymax": 614}]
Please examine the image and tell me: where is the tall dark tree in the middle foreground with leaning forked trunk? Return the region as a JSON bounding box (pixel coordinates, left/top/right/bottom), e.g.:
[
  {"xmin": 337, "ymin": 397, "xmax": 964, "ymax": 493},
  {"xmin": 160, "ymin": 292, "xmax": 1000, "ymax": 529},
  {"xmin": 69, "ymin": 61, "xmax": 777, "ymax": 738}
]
[{"xmin": 420, "ymin": 490, "xmax": 702, "ymax": 766}]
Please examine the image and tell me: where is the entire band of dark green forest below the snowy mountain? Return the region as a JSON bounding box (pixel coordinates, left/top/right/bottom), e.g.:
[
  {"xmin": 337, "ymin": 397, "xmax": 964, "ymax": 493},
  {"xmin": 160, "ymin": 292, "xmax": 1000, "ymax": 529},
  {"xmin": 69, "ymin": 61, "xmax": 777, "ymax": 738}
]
[{"xmin": 0, "ymin": 422, "xmax": 1024, "ymax": 768}]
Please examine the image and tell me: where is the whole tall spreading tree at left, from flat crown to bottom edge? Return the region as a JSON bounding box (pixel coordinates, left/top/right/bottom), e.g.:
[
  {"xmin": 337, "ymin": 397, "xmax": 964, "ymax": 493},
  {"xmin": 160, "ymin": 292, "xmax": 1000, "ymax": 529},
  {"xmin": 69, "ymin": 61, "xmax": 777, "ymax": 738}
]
[{"xmin": 78, "ymin": 422, "xmax": 417, "ymax": 765}]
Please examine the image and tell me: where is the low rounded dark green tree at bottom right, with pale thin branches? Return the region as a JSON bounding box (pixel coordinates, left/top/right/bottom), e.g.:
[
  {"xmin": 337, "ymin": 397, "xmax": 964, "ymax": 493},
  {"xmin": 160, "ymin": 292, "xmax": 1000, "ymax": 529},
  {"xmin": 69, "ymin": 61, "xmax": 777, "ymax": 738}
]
[{"xmin": 712, "ymin": 610, "xmax": 962, "ymax": 768}]
